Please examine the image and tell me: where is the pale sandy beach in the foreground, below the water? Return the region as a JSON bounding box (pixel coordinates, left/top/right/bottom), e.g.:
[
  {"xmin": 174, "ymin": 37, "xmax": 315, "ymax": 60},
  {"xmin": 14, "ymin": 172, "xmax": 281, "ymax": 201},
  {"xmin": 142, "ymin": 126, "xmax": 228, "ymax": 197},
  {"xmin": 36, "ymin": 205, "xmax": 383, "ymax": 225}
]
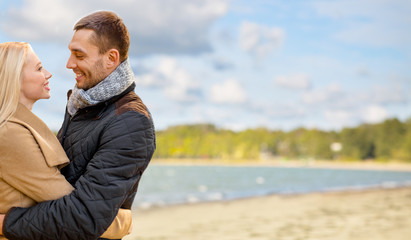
[{"xmin": 124, "ymin": 187, "xmax": 411, "ymax": 240}]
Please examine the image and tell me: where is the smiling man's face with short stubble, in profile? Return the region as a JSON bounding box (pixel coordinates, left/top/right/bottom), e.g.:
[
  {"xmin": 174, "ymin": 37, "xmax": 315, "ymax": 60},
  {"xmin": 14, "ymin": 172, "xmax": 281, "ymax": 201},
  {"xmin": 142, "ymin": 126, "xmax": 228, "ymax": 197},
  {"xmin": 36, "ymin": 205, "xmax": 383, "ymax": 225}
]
[{"xmin": 66, "ymin": 29, "xmax": 108, "ymax": 90}]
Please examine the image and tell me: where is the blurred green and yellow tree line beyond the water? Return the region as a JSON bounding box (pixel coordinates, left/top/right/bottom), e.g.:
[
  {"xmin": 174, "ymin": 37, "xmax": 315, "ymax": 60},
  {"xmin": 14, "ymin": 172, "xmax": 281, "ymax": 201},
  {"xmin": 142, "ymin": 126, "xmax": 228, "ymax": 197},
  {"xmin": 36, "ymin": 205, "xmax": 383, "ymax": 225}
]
[{"xmin": 154, "ymin": 118, "xmax": 411, "ymax": 162}]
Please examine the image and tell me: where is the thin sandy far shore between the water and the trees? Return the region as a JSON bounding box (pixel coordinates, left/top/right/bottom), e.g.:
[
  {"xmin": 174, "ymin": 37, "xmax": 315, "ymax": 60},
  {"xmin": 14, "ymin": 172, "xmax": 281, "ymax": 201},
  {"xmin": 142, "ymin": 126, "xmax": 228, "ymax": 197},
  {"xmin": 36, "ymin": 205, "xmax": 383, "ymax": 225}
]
[{"xmin": 151, "ymin": 159, "xmax": 411, "ymax": 171}]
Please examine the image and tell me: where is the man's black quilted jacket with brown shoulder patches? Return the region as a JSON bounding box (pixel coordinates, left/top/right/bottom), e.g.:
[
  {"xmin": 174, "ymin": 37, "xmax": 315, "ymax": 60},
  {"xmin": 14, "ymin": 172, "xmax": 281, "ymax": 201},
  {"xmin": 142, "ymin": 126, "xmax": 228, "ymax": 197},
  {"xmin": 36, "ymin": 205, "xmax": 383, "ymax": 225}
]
[{"xmin": 3, "ymin": 84, "xmax": 155, "ymax": 240}]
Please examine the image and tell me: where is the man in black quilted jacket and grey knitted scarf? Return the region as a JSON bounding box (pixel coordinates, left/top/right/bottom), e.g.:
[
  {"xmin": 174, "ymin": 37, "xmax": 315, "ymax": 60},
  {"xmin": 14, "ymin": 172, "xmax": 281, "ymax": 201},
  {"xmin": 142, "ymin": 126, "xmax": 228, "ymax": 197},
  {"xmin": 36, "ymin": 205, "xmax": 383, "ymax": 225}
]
[{"xmin": 3, "ymin": 11, "xmax": 155, "ymax": 240}]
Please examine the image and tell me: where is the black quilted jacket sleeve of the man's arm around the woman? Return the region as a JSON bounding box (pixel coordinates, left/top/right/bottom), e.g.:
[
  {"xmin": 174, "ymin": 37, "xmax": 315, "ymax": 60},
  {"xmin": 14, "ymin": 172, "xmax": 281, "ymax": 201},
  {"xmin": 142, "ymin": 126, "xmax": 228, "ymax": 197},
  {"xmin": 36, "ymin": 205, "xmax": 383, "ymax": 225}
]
[{"xmin": 3, "ymin": 111, "xmax": 155, "ymax": 240}]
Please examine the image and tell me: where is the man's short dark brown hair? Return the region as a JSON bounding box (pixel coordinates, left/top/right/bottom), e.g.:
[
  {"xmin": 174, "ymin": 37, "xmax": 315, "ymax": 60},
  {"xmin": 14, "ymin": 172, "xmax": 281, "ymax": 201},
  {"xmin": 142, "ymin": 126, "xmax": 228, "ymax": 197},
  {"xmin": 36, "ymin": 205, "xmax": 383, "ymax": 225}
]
[{"xmin": 74, "ymin": 11, "xmax": 130, "ymax": 62}]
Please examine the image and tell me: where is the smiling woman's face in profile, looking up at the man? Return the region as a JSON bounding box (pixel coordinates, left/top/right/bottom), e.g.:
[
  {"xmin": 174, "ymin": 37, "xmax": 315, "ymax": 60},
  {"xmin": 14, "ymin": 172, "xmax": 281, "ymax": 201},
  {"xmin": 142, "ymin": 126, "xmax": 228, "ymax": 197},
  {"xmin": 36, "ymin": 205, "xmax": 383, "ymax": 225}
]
[{"xmin": 20, "ymin": 48, "xmax": 52, "ymax": 105}]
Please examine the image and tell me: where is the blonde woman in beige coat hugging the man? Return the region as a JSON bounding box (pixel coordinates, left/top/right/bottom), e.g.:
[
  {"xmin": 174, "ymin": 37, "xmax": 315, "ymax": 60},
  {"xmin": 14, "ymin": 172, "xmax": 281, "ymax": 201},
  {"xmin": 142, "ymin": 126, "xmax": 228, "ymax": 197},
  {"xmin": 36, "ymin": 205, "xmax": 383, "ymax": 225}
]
[{"xmin": 0, "ymin": 42, "xmax": 131, "ymax": 239}]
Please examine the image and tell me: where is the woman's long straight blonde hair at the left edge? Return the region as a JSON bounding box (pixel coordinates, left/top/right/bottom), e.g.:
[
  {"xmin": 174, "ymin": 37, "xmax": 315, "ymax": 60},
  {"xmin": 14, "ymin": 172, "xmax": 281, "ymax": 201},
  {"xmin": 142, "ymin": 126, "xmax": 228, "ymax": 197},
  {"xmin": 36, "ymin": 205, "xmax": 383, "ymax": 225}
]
[{"xmin": 0, "ymin": 42, "xmax": 31, "ymax": 127}]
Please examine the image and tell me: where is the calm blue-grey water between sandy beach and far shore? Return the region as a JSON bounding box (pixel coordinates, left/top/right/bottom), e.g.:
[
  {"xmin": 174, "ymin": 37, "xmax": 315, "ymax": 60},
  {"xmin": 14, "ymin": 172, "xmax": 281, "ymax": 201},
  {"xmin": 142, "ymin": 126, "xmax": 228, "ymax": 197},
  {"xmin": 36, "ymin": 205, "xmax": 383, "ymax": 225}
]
[{"xmin": 134, "ymin": 165, "xmax": 411, "ymax": 208}]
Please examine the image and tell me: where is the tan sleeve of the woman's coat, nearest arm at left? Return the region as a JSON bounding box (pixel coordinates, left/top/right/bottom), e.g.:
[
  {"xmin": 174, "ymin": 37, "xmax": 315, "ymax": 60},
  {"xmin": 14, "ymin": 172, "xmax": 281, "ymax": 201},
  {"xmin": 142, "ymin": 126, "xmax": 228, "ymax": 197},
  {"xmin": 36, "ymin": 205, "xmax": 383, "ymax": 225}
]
[{"xmin": 0, "ymin": 123, "xmax": 73, "ymax": 202}]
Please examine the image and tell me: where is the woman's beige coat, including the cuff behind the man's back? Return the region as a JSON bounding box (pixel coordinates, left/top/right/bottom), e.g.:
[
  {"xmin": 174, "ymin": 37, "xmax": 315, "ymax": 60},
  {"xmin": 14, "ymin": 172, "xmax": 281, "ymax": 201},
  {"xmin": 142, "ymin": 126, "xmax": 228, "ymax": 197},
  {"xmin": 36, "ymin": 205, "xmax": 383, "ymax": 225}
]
[{"xmin": 0, "ymin": 104, "xmax": 131, "ymax": 239}]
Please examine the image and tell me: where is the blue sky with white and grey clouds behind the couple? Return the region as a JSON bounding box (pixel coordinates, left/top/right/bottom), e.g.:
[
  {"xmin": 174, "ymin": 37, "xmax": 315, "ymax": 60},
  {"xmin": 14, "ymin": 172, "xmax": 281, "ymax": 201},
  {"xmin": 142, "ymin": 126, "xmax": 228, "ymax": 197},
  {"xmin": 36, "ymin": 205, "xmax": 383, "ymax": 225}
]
[{"xmin": 0, "ymin": 0, "xmax": 411, "ymax": 131}]
